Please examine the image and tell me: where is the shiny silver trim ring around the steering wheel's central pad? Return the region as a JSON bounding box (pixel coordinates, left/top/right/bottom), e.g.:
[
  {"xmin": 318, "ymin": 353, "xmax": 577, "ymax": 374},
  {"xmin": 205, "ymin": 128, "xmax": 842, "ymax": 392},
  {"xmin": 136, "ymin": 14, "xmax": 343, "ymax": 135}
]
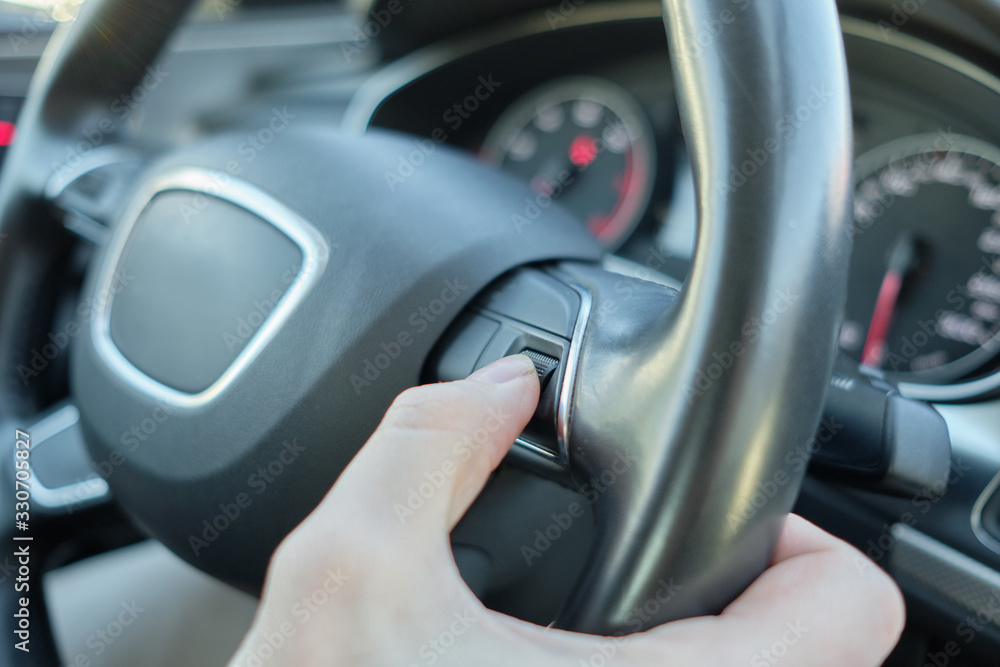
[{"xmin": 91, "ymin": 167, "xmax": 330, "ymax": 409}]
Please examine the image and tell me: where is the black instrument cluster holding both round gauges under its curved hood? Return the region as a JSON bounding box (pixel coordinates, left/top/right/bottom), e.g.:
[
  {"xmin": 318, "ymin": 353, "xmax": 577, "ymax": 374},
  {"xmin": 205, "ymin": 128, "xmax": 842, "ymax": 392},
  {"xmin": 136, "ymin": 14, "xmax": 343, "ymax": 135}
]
[{"xmin": 347, "ymin": 11, "xmax": 1000, "ymax": 400}]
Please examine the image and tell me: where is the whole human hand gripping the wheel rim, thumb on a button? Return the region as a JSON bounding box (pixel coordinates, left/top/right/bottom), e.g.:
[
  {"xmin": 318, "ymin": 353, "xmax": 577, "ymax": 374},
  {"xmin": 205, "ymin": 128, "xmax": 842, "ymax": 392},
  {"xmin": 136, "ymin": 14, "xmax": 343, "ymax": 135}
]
[{"xmin": 232, "ymin": 355, "xmax": 904, "ymax": 667}]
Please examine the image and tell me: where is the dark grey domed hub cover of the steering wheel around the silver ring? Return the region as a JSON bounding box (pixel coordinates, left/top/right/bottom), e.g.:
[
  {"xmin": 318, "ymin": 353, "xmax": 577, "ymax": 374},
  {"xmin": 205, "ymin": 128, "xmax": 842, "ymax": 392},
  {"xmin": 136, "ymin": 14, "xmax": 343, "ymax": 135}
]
[{"xmin": 71, "ymin": 123, "xmax": 602, "ymax": 590}]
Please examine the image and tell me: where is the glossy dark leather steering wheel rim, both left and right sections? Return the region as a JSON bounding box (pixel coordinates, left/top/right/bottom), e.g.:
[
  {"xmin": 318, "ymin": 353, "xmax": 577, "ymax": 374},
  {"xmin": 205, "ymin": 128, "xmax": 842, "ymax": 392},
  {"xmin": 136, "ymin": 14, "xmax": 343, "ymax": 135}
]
[{"xmin": 0, "ymin": 0, "xmax": 851, "ymax": 634}]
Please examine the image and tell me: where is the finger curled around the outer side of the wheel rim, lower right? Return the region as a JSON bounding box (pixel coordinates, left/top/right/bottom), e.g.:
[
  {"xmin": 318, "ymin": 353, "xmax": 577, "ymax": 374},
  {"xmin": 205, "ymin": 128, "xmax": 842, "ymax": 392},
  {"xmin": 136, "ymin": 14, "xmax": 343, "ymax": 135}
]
[{"xmin": 654, "ymin": 515, "xmax": 905, "ymax": 667}]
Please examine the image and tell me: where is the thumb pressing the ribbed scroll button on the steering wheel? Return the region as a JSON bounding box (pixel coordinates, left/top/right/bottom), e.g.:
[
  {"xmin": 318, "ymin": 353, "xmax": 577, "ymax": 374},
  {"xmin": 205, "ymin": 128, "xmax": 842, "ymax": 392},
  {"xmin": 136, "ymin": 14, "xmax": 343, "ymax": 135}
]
[{"xmin": 321, "ymin": 354, "xmax": 539, "ymax": 544}]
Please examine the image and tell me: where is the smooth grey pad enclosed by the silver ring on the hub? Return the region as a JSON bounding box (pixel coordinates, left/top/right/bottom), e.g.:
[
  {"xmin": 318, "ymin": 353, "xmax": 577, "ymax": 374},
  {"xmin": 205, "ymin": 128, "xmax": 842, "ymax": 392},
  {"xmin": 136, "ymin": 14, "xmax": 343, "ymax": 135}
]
[{"xmin": 111, "ymin": 190, "xmax": 302, "ymax": 393}]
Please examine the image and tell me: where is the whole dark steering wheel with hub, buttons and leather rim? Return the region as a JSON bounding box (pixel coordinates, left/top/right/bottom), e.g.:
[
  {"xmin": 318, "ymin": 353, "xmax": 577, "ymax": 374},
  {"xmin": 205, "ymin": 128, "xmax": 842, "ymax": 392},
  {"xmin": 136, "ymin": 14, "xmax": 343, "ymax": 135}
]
[{"xmin": 0, "ymin": 0, "xmax": 852, "ymax": 656}]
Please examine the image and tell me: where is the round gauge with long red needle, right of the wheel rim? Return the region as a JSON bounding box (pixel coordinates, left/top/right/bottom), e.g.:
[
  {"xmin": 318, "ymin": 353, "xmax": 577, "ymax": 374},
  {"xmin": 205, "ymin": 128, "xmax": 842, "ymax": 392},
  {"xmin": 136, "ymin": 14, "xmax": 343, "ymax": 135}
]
[{"xmin": 840, "ymin": 134, "xmax": 1000, "ymax": 384}]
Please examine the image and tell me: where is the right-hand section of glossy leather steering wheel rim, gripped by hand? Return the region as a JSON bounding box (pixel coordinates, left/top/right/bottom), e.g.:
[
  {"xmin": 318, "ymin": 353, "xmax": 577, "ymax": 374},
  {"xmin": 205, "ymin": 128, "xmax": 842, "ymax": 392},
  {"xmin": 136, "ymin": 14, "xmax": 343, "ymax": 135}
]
[{"xmin": 558, "ymin": 0, "xmax": 852, "ymax": 632}]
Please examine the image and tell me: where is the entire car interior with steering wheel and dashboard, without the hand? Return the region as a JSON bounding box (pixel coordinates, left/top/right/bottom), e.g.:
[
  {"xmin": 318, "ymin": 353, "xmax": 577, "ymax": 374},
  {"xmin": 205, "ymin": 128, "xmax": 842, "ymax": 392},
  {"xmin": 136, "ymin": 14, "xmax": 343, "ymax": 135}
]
[{"xmin": 0, "ymin": 0, "xmax": 1000, "ymax": 667}]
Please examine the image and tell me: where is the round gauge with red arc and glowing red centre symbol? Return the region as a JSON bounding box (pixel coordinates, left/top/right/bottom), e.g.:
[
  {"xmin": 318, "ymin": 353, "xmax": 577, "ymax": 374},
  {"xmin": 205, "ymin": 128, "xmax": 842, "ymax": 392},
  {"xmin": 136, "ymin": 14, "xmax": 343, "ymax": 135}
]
[{"xmin": 482, "ymin": 77, "xmax": 655, "ymax": 249}]
